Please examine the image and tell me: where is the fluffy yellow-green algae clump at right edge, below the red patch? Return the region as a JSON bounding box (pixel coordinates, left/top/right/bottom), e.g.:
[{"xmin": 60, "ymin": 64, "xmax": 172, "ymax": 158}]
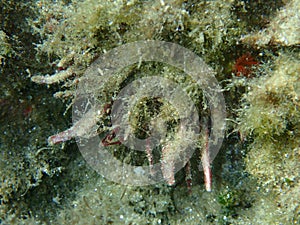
[{"xmin": 239, "ymin": 52, "xmax": 300, "ymax": 223}]
